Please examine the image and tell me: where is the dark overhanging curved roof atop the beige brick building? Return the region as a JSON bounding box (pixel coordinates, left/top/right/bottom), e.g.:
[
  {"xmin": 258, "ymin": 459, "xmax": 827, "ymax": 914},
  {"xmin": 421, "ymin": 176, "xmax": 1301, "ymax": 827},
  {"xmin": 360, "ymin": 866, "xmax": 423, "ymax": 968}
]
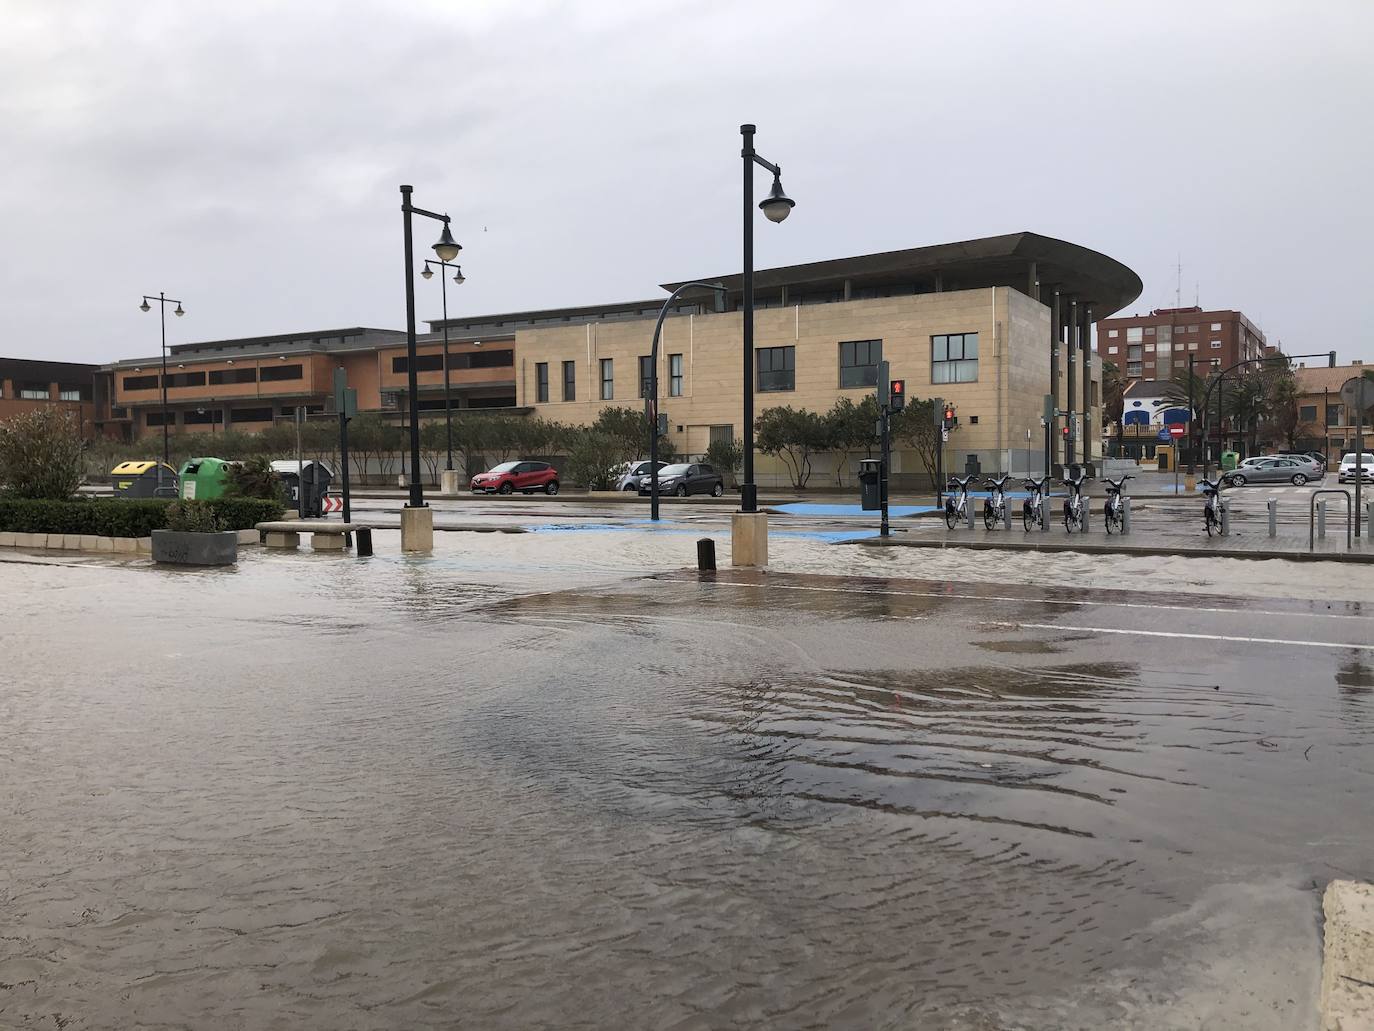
[{"xmin": 662, "ymin": 232, "xmax": 1143, "ymax": 319}]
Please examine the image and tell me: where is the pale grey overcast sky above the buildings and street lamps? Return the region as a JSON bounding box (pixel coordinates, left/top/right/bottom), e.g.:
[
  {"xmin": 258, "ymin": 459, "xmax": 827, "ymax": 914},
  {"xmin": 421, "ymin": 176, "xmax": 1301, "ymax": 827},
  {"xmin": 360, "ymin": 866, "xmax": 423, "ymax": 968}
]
[{"xmin": 0, "ymin": 0, "xmax": 1374, "ymax": 362}]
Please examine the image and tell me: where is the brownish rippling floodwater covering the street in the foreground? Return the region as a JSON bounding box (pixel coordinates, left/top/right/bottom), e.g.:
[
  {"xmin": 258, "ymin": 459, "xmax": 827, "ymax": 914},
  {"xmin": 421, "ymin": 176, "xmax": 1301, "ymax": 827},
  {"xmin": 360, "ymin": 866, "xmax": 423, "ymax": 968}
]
[{"xmin": 0, "ymin": 529, "xmax": 1374, "ymax": 1030}]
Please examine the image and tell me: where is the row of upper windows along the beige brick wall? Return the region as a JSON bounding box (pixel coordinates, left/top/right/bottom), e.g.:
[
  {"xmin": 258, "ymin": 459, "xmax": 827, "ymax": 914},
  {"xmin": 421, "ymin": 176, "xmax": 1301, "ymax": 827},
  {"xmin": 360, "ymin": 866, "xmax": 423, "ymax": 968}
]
[{"xmin": 534, "ymin": 339, "xmax": 978, "ymax": 404}]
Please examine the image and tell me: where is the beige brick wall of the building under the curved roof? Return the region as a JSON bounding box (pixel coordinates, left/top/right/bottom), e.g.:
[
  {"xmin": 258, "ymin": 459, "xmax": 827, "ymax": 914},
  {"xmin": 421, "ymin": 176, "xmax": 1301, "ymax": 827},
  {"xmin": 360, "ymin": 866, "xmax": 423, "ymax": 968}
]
[{"xmin": 515, "ymin": 287, "xmax": 1088, "ymax": 485}]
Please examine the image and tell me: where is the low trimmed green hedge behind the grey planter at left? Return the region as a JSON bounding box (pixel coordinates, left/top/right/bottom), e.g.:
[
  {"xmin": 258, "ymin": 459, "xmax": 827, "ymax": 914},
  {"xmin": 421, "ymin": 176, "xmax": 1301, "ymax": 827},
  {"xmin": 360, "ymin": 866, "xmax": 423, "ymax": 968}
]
[{"xmin": 0, "ymin": 498, "xmax": 282, "ymax": 537}]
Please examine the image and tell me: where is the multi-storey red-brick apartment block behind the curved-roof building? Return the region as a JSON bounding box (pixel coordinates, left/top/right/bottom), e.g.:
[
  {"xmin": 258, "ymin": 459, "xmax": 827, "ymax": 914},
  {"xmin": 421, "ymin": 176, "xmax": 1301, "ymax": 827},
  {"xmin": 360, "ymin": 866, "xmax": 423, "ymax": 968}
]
[{"xmin": 1098, "ymin": 308, "xmax": 1272, "ymax": 381}]
